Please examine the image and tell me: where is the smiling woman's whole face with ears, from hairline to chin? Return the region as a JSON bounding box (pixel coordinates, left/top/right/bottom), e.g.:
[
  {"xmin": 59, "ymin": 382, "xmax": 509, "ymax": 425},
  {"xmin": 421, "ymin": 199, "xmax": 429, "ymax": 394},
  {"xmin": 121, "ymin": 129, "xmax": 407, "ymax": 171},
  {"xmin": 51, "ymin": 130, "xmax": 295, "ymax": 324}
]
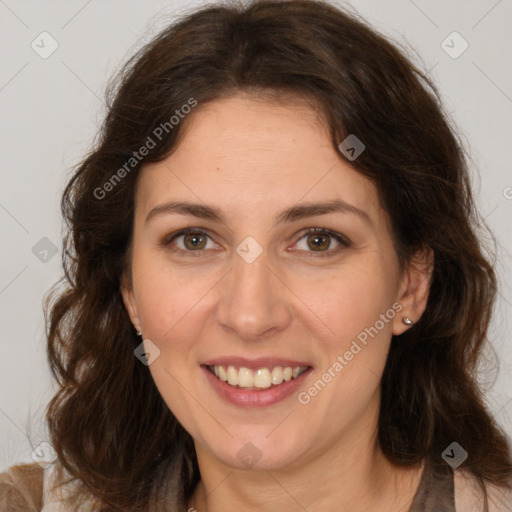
[{"xmin": 122, "ymin": 96, "xmax": 426, "ymax": 469}]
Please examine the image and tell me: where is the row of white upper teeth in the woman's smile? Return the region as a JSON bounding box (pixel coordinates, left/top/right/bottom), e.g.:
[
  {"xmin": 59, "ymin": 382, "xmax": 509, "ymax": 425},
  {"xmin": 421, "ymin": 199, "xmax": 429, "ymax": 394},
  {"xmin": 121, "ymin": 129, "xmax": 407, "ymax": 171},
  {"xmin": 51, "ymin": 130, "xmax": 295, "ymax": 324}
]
[{"xmin": 210, "ymin": 366, "xmax": 308, "ymax": 389}]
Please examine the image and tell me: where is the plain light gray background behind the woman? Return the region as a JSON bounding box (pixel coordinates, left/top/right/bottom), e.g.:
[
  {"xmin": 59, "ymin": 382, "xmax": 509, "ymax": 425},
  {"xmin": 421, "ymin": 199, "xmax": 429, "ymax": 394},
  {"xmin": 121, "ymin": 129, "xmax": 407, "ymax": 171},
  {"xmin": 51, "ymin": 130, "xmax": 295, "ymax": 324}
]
[{"xmin": 0, "ymin": 0, "xmax": 512, "ymax": 470}]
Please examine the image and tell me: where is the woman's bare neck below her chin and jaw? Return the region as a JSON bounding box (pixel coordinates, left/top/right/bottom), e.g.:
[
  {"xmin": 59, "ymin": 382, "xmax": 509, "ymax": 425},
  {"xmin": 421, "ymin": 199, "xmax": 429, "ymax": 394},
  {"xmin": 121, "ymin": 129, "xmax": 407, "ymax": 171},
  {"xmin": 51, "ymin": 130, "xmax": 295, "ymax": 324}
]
[{"xmin": 188, "ymin": 400, "xmax": 423, "ymax": 512}]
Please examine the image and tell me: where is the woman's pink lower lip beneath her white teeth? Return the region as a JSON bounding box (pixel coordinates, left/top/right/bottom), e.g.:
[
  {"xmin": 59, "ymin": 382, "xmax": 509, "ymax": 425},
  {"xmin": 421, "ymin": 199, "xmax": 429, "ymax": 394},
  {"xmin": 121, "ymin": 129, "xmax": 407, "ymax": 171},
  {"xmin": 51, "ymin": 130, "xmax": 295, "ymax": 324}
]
[{"xmin": 201, "ymin": 366, "xmax": 312, "ymax": 407}]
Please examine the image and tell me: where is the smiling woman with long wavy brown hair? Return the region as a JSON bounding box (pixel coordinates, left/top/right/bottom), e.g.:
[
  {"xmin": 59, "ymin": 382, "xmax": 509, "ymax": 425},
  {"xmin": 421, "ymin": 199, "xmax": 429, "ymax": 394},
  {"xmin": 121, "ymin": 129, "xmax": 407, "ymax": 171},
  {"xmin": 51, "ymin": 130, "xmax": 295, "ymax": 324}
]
[{"xmin": 4, "ymin": 0, "xmax": 512, "ymax": 512}]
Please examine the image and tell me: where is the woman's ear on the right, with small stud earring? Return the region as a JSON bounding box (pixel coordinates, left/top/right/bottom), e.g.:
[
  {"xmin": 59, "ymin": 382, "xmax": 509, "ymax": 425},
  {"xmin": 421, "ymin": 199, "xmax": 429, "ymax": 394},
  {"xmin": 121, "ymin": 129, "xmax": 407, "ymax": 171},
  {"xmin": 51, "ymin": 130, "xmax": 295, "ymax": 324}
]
[{"xmin": 393, "ymin": 247, "xmax": 434, "ymax": 336}]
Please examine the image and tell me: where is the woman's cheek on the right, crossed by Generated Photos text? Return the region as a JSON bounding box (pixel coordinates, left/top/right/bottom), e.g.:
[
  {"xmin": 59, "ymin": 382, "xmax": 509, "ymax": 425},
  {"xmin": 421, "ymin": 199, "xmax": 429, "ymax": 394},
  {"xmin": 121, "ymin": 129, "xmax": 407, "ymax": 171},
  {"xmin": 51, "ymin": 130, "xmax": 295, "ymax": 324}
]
[{"xmin": 290, "ymin": 258, "xmax": 397, "ymax": 416}]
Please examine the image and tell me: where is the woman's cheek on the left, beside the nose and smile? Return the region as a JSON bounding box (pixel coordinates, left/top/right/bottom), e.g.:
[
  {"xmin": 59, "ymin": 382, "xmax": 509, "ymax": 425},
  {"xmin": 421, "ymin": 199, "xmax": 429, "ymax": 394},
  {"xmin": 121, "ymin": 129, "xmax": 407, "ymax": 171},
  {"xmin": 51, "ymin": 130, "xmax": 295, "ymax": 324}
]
[{"xmin": 134, "ymin": 262, "xmax": 218, "ymax": 424}]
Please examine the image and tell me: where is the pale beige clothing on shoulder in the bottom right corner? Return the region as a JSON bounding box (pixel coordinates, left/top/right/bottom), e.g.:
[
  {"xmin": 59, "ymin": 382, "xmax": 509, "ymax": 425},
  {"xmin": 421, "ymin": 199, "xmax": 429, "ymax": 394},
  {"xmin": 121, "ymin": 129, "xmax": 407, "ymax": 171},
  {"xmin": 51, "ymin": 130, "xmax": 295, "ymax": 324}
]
[{"xmin": 454, "ymin": 470, "xmax": 512, "ymax": 512}]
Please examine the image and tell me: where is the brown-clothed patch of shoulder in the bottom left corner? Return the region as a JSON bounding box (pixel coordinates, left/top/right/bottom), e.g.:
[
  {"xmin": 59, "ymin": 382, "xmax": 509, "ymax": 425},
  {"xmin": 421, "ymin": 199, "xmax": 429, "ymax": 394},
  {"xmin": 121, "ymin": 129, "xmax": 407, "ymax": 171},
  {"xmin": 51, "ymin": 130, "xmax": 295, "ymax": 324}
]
[{"xmin": 0, "ymin": 463, "xmax": 44, "ymax": 512}]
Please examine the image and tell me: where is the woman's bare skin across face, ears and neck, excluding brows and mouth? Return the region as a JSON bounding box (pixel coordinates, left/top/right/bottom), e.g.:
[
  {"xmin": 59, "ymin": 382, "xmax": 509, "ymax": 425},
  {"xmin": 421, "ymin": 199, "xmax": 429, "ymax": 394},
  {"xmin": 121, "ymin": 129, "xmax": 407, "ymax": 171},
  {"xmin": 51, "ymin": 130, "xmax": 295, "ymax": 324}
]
[{"xmin": 122, "ymin": 94, "xmax": 432, "ymax": 512}]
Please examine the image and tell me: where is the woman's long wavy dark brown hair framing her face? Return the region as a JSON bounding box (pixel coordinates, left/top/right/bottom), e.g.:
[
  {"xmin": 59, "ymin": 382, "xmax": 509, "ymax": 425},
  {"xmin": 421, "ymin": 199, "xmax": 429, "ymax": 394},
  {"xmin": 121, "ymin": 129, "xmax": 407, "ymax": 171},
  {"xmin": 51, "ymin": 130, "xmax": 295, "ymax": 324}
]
[{"xmin": 45, "ymin": 0, "xmax": 512, "ymax": 511}]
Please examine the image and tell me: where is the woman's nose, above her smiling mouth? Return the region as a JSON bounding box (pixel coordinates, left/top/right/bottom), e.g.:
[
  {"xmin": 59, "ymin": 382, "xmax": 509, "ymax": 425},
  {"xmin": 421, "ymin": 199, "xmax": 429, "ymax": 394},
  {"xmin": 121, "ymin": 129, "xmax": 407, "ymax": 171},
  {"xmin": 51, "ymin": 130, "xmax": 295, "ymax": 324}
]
[{"xmin": 217, "ymin": 247, "xmax": 292, "ymax": 341}]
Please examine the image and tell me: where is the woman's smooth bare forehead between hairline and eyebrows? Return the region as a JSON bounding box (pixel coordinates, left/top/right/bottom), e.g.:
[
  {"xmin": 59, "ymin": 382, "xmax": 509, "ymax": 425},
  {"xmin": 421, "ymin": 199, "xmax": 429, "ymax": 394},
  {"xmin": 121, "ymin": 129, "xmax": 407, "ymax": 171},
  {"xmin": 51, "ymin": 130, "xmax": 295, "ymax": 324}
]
[{"xmin": 137, "ymin": 95, "xmax": 382, "ymax": 226}]
